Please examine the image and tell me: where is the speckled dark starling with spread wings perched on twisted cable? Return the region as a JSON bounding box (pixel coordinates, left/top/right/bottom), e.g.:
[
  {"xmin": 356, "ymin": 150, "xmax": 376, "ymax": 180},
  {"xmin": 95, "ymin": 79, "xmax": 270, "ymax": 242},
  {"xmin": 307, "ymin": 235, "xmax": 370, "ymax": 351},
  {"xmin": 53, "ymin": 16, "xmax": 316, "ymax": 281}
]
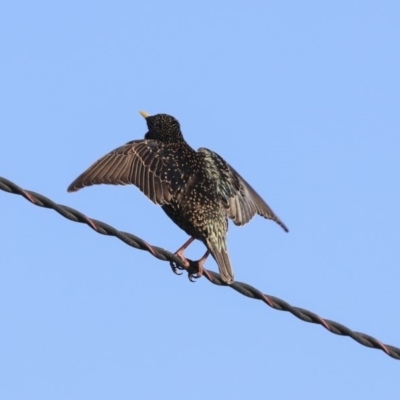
[{"xmin": 67, "ymin": 111, "xmax": 289, "ymax": 285}]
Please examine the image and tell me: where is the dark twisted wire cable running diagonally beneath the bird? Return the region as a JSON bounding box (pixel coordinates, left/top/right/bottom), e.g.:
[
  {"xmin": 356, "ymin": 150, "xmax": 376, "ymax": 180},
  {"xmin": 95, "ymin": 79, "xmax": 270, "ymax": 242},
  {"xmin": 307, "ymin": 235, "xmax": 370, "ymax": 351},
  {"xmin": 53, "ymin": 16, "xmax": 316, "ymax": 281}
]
[{"xmin": 0, "ymin": 176, "xmax": 400, "ymax": 360}]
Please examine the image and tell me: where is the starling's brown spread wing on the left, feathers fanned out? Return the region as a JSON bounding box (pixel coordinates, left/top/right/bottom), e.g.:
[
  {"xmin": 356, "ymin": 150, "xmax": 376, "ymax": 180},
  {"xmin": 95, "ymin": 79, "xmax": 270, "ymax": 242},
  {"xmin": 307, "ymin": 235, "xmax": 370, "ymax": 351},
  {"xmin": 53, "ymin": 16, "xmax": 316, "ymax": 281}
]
[{"xmin": 68, "ymin": 140, "xmax": 175, "ymax": 205}]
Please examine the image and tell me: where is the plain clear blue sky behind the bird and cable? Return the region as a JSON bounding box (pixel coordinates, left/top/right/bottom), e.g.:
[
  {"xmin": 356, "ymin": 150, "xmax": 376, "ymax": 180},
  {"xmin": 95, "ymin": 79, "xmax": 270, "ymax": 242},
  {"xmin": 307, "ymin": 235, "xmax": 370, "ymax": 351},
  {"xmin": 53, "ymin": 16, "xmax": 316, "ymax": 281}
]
[{"xmin": 0, "ymin": 0, "xmax": 400, "ymax": 400}]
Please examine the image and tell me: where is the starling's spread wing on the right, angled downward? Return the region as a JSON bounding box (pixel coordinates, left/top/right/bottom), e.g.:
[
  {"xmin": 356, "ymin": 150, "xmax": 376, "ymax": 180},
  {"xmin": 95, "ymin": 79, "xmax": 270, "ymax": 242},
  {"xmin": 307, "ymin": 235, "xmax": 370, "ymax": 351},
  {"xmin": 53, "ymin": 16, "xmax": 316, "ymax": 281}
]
[{"xmin": 199, "ymin": 148, "xmax": 289, "ymax": 232}]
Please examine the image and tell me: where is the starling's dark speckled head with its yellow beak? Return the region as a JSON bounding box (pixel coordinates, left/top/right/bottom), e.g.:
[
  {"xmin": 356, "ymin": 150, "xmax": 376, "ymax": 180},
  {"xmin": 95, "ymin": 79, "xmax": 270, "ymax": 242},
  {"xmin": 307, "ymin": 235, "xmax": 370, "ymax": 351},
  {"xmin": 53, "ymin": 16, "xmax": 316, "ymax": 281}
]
[{"xmin": 140, "ymin": 111, "xmax": 183, "ymax": 143}]
